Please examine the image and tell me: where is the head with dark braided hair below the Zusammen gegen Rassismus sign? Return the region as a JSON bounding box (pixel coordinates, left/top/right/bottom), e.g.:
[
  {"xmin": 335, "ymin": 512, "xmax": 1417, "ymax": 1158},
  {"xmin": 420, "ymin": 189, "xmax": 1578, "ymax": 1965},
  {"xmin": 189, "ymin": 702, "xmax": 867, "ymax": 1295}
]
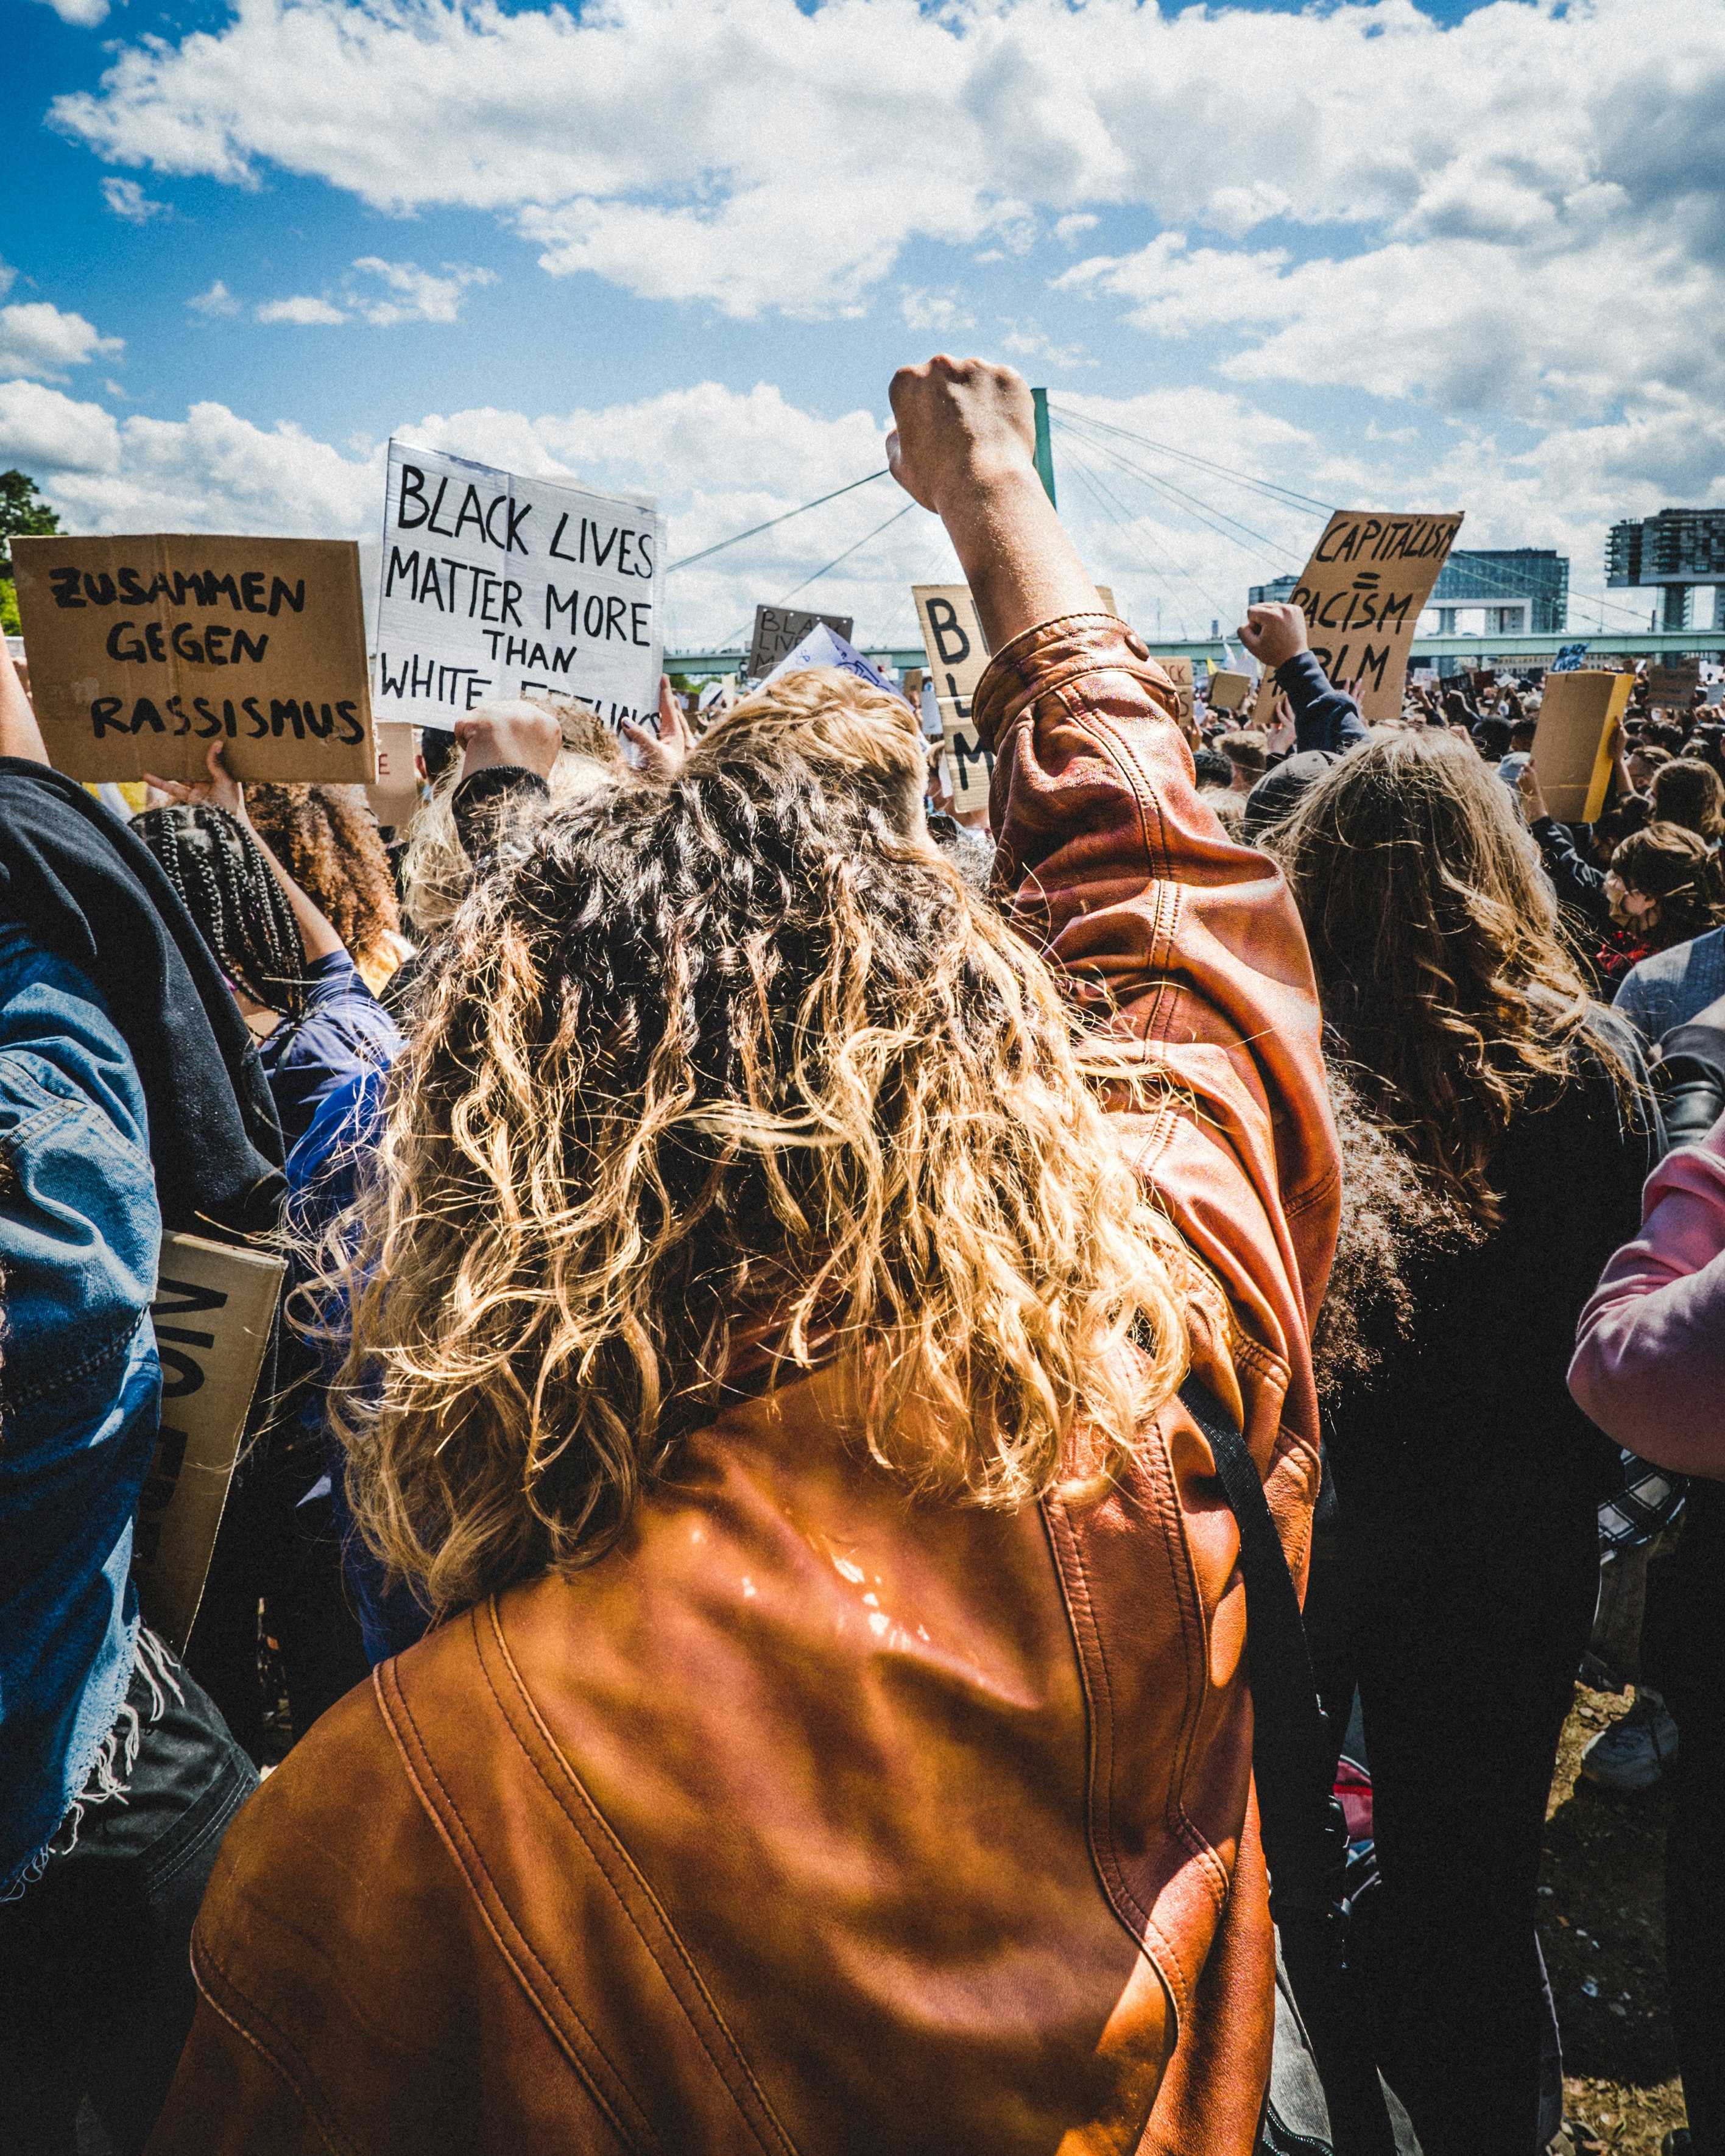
[{"xmin": 132, "ymin": 806, "xmax": 306, "ymax": 1018}]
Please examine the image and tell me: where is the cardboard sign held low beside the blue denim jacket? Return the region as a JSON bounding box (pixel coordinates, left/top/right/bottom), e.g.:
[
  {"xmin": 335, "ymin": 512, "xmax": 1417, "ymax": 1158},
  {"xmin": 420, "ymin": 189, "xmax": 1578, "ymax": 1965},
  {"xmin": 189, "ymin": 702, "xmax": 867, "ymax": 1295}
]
[{"xmin": 132, "ymin": 1235, "xmax": 287, "ymax": 1654}]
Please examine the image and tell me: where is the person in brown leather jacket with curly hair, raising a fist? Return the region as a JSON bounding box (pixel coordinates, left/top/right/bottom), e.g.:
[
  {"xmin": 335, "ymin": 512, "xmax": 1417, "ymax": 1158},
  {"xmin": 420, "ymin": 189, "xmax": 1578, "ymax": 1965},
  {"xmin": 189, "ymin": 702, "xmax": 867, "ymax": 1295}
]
[{"xmin": 155, "ymin": 358, "xmax": 1337, "ymax": 2156}]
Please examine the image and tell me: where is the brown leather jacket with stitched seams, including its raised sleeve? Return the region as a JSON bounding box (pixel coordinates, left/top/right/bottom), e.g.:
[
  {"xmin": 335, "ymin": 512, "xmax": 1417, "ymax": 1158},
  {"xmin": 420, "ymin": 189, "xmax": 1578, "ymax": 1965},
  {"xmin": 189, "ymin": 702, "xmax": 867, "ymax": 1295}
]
[{"xmin": 151, "ymin": 615, "xmax": 1337, "ymax": 2156}]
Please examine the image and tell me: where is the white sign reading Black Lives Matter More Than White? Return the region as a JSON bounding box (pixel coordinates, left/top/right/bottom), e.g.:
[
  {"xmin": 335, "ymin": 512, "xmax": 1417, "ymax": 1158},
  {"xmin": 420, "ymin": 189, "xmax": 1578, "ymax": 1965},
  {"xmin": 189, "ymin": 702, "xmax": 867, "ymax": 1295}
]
[{"xmin": 373, "ymin": 442, "xmax": 664, "ymax": 729}]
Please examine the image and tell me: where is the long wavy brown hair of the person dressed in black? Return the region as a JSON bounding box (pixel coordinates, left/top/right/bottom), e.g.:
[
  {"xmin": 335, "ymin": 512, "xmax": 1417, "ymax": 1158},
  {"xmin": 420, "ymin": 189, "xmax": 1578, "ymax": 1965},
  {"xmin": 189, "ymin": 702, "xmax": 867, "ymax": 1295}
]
[{"xmin": 1274, "ymin": 733, "xmax": 1621, "ymax": 1222}]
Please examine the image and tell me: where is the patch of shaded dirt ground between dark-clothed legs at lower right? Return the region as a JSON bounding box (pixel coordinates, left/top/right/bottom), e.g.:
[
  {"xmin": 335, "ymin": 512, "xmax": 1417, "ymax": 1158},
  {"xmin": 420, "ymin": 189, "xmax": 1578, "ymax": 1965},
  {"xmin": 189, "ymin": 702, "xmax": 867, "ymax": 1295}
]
[{"xmin": 1540, "ymin": 1686, "xmax": 1684, "ymax": 2156}]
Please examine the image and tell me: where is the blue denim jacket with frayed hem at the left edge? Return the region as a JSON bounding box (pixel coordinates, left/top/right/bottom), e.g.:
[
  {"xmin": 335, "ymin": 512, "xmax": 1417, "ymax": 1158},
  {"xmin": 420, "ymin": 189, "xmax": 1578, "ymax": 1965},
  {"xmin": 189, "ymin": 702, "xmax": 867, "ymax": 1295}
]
[{"xmin": 0, "ymin": 925, "xmax": 162, "ymax": 1895}]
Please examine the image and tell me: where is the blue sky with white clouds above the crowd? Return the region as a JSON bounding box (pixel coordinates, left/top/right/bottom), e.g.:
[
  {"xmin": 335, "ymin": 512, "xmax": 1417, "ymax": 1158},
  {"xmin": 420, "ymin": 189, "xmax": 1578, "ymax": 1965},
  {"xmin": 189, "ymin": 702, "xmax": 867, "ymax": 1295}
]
[{"xmin": 0, "ymin": 0, "xmax": 1725, "ymax": 647}]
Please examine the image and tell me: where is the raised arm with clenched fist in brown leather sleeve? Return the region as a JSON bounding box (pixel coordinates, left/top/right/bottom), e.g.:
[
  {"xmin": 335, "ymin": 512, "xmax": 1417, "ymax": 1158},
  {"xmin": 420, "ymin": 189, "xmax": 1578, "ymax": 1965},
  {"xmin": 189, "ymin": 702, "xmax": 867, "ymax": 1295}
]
[{"xmin": 888, "ymin": 360, "xmax": 1339, "ymax": 1509}]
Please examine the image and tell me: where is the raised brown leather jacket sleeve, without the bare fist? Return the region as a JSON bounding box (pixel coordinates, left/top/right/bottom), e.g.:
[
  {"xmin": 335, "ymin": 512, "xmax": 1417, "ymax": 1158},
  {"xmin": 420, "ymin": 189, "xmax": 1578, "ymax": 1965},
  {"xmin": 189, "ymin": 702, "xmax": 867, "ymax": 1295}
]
[{"xmin": 975, "ymin": 615, "xmax": 1339, "ymax": 1535}]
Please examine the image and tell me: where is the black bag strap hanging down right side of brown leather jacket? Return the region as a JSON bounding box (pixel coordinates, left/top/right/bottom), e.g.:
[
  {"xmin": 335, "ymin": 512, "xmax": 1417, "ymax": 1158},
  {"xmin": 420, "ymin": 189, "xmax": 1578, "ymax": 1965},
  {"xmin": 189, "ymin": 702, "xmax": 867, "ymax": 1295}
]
[{"xmin": 1179, "ymin": 1378, "xmax": 1395, "ymax": 2156}]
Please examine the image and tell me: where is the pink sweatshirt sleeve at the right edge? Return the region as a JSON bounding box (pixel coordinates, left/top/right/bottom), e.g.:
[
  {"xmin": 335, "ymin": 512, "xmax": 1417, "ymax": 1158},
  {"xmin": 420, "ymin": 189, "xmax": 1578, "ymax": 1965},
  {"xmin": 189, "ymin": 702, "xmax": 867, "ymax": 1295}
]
[{"xmin": 1570, "ymin": 1117, "xmax": 1725, "ymax": 1479}]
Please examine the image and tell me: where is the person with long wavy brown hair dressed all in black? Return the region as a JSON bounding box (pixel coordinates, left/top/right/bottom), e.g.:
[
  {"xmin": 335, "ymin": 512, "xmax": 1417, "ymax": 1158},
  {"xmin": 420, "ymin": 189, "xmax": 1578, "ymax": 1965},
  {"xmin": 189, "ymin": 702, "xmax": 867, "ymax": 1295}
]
[{"xmin": 1277, "ymin": 733, "xmax": 1656, "ymax": 2156}]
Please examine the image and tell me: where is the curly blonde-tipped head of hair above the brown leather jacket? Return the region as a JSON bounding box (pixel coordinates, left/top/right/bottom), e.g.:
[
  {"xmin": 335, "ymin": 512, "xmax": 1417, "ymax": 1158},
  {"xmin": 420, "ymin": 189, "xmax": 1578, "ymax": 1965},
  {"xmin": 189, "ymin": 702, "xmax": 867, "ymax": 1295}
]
[{"xmin": 332, "ymin": 679, "xmax": 1184, "ymax": 1608}]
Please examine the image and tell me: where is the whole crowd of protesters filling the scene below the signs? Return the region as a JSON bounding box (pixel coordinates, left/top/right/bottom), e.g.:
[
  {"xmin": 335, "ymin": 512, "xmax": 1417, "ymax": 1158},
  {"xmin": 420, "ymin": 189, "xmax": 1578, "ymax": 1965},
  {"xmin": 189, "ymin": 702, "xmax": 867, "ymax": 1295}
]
[{"xmin": 0, "ymin": 360, "xmax": 1725, "ymax": 2156}]
